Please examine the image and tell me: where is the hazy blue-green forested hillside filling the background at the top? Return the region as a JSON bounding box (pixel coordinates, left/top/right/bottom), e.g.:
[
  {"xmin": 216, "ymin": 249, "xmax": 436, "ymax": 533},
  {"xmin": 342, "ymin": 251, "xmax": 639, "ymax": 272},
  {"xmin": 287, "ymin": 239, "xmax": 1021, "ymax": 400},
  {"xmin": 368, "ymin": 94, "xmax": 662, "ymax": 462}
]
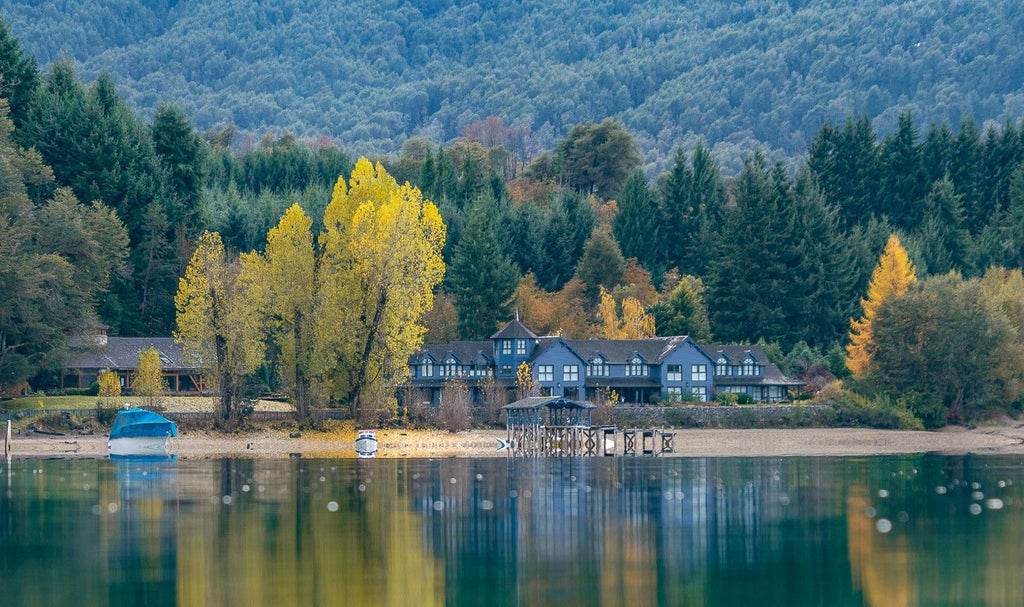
[{"xmin": 0, "ymin": 0, "xmax": 1024, "ymax": 171}]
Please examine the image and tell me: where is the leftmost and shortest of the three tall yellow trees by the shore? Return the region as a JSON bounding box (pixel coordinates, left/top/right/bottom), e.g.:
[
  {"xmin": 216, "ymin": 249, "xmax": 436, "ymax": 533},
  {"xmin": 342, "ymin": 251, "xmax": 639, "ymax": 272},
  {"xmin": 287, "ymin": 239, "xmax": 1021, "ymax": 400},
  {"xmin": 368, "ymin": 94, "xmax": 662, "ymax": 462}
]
[{"xmin": 174, "ymin": 232, "xmax": 264, "ymax": 422}]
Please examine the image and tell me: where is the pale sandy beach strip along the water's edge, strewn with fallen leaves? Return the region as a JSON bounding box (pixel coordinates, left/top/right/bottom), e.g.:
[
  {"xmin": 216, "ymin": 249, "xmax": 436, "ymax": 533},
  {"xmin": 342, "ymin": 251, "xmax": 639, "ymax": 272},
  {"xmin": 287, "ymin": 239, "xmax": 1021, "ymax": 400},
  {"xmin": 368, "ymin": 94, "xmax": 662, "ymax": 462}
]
[{"xmin": 11, "ymin": 422, "xmax": 1024, "ymax": 460}]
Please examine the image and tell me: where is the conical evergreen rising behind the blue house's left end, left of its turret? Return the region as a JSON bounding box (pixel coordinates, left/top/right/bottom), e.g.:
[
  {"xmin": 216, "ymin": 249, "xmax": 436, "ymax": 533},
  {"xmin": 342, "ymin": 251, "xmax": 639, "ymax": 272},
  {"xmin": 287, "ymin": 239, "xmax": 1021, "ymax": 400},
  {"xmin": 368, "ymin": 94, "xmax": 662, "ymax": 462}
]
[{"xmin": 444, "ymin": 191, "xmax": 519, "ymax": 340}]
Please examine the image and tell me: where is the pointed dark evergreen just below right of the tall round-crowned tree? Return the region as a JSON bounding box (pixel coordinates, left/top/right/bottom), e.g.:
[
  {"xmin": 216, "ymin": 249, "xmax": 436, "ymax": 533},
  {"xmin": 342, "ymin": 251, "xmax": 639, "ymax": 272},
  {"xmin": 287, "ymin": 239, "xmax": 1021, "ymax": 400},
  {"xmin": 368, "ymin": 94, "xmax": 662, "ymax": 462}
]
[{"xmin": 611, "ymin": 170, "xmax": 663, "ymax": 275}]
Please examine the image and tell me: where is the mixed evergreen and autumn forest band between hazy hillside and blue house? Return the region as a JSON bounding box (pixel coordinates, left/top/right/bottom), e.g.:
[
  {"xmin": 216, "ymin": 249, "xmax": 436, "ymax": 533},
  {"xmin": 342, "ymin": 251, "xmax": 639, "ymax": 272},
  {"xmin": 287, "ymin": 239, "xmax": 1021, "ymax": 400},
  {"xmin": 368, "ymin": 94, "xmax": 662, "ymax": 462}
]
[{"xmin": 0, "ymin": 14, "xmax": 1024, "ymax": 426}]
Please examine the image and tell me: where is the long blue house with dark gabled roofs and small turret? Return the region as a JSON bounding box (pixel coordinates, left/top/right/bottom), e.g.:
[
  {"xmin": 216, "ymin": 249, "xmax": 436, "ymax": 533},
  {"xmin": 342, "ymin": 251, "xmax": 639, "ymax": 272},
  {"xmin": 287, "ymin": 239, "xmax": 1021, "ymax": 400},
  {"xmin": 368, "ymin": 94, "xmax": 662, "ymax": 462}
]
[{"xmin": 409, "ymin": 319, "xmax": 799, "ymax": 404}]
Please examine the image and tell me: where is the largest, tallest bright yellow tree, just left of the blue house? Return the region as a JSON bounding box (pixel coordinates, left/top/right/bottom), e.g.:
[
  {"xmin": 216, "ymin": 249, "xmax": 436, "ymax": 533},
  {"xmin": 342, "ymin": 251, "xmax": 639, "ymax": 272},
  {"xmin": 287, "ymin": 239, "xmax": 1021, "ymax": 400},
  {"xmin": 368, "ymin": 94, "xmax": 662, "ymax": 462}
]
[{"xmin": 312, "ymin": 159, "xmax": 445, "ymax": 417}]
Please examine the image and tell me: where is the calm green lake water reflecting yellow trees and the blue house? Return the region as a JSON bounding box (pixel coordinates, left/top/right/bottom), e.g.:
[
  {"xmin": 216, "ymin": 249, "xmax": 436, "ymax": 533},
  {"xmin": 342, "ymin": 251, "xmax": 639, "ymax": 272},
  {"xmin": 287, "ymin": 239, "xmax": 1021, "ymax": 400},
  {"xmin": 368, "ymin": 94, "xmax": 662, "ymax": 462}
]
[{"xmin": 0, "ymin": 456, "xmax": 1024, "ymax": 607}]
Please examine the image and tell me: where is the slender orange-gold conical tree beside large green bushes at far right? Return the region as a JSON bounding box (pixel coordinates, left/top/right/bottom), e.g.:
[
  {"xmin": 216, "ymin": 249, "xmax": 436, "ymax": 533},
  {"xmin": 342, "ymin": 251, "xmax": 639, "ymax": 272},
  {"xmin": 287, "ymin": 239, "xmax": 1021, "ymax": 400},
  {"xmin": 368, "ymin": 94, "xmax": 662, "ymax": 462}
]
[{"xmin": 846, "ymin": 234, "xmax": 918, "ymax": 379}]
